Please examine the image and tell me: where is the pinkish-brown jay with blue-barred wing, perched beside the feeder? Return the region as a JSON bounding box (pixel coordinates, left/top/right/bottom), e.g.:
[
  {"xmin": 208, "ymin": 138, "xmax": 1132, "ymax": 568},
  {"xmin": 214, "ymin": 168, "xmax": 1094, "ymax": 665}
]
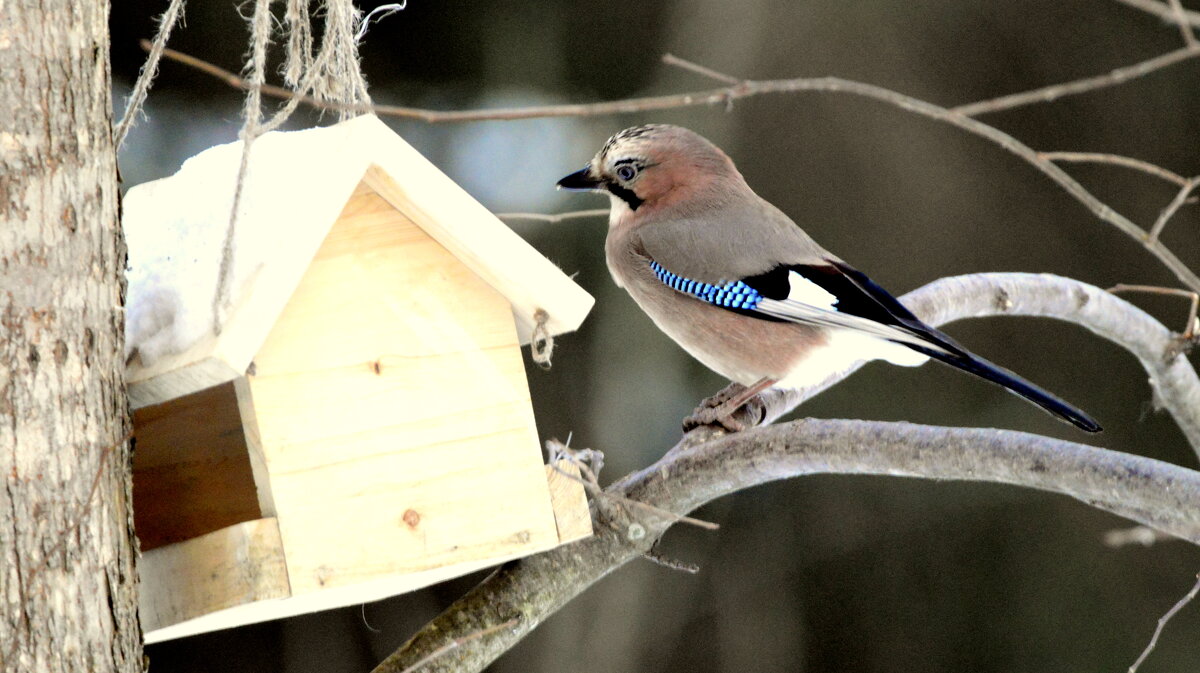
[{"xmin": 557, "ymin": 124, "xmax": 1100, "ymax": 432}]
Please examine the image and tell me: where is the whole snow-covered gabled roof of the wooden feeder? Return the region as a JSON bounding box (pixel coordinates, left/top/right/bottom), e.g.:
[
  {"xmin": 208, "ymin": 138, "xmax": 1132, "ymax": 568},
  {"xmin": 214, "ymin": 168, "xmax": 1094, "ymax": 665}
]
[{"xmin": 122, "ymin": 115, "xmax": 594, "ymax": 407}]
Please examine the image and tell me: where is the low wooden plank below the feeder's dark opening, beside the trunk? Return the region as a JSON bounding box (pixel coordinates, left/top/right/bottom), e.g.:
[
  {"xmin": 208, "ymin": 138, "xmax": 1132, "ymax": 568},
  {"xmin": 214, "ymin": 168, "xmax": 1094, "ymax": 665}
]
[{"xmin": 138, "ymin": 518, "xmax": 290, "ymax": 641}]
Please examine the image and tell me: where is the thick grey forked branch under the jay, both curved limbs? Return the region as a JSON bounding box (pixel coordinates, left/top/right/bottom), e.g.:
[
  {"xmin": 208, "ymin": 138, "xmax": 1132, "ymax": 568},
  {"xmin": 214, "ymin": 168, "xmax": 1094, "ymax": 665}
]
[{"xmin": 376, "ymin": 274, "xmax": 1200, "ymax": 673}]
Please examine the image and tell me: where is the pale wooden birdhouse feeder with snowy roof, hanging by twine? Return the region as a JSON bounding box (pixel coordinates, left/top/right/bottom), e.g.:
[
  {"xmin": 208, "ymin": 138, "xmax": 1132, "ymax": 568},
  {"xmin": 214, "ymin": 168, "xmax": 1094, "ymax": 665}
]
[{"xmin": 124, "ymin": 116, "xmax": 593, "ymax": 642}]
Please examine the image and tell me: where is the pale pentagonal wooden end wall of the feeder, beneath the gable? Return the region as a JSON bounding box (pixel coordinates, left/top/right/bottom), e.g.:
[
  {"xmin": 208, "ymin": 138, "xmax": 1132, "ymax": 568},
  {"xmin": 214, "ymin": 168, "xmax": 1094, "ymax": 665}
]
[{"xmin": 246, "ymin": 183, "xmax": 558, "ymax": 595}]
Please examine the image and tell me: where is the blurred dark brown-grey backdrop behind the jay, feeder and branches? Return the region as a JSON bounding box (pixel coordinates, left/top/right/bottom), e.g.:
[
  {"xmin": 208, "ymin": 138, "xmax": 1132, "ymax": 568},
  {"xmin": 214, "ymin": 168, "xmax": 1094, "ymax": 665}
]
[{"xmin": 112, "ymin": 0, "xmax": 1200, "ymax": 673}]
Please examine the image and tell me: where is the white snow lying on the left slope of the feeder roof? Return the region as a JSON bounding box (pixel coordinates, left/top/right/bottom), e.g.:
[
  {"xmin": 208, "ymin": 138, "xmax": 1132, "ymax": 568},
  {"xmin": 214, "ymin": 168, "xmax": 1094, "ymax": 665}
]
[{"xmin": 121, "ymin": 126, "xmax": 364, "ymax": 368}]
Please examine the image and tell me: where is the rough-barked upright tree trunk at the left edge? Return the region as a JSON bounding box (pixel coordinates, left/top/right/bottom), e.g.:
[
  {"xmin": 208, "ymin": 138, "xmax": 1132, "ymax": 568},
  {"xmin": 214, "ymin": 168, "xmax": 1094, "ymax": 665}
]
[{"xmin": 0, "ymin": 0, "xmax": 143, "ymax": 672}]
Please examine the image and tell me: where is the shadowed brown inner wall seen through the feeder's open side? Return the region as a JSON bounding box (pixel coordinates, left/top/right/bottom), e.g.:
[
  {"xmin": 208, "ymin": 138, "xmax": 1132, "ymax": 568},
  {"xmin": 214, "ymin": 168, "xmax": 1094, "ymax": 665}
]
[{"xmin": 133, "ymin": 383, "xmax": 263, "ymax": 551}]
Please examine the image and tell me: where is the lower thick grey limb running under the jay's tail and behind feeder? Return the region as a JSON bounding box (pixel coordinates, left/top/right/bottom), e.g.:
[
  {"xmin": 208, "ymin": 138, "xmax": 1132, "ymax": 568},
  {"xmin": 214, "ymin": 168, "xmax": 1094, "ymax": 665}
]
[{"xmin": 376, "ymin": 420, "xmax": 1200, "ymax": 673}]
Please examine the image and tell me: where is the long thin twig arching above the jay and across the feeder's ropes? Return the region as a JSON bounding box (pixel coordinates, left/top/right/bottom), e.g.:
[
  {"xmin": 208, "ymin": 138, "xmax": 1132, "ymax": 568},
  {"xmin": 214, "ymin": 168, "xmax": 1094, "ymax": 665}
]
[{"xmin": 147, "ymin": 43, "xmax": 1200, "ymax": 292}]
